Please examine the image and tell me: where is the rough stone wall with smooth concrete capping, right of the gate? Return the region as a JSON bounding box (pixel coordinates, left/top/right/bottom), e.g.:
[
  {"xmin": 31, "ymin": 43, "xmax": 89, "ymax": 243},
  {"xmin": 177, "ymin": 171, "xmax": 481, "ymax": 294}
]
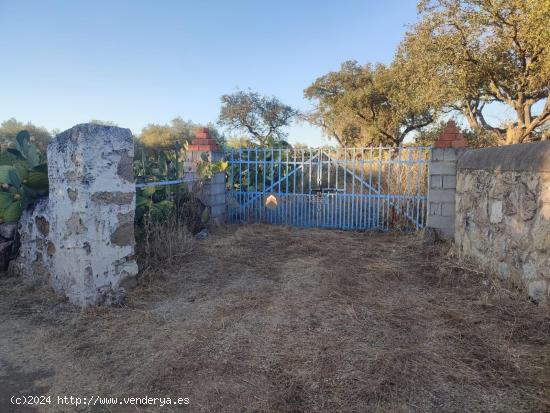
[{"xmin": 455, "ymin": 142, "xmax": 550, "ymax": 301}]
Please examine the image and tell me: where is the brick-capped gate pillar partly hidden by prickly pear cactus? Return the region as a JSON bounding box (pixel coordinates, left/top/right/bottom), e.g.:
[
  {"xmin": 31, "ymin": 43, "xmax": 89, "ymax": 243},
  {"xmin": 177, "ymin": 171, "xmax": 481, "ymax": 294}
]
[{"xmin": 184, "ymin": 128, "xmax": 225, "ymax": 224}]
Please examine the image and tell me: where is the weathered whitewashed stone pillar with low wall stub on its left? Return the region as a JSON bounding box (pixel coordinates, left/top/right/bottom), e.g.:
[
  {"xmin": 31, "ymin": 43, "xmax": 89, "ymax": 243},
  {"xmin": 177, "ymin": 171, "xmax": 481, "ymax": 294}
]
[{"xmin": 12, "ymin": 124, "xmax": 137, "ymax": 306}]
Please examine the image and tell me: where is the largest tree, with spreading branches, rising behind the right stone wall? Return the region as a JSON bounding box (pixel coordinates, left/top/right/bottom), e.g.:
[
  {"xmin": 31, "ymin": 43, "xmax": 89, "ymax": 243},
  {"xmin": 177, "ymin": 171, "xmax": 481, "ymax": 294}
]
[{"xmin": 396, "ymin": 0, "xmax": 550, "ymax": 144}]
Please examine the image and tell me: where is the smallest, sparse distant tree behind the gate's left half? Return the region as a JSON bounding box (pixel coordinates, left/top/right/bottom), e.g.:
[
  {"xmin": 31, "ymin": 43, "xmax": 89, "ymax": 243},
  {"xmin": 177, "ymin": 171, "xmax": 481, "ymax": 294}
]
[{"xmin": 218, "ymin": 91, "xmax": 298, "ymax": 146}]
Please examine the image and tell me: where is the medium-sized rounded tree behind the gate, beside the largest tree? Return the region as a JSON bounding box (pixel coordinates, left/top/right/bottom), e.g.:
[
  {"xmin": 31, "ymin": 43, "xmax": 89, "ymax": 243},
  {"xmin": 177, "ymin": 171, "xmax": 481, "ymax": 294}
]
[{"xmin": 304, "ymin": 61, "xmax": 434, "ymax": 146}]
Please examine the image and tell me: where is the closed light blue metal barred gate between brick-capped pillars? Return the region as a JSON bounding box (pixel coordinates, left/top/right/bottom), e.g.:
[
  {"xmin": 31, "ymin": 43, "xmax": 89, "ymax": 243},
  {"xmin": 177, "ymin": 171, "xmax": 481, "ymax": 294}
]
[{"xmin": 226, "ymin": 146, "xmax": 429, "ymax": 230}]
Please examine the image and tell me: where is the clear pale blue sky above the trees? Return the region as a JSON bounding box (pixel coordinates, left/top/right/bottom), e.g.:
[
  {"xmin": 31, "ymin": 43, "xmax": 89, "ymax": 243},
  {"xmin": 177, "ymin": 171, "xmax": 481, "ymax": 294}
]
[{"xmin": 0, "ymin": 0, "xmax": 416, "ymax": 145}]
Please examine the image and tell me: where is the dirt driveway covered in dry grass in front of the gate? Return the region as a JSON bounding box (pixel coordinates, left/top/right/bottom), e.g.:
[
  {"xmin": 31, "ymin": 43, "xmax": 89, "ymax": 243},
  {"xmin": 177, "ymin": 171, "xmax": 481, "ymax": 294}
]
[{"xmin": 0, "ymin": 225, "xmax": 550, "ymax": 412}]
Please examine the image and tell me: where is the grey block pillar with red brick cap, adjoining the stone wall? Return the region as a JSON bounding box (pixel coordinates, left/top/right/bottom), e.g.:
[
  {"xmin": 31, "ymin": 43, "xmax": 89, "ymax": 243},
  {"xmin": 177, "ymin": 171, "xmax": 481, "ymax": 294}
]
[{"xmin": 427, "ymin": 120, "xmax": 467, "ymax": 239}]
